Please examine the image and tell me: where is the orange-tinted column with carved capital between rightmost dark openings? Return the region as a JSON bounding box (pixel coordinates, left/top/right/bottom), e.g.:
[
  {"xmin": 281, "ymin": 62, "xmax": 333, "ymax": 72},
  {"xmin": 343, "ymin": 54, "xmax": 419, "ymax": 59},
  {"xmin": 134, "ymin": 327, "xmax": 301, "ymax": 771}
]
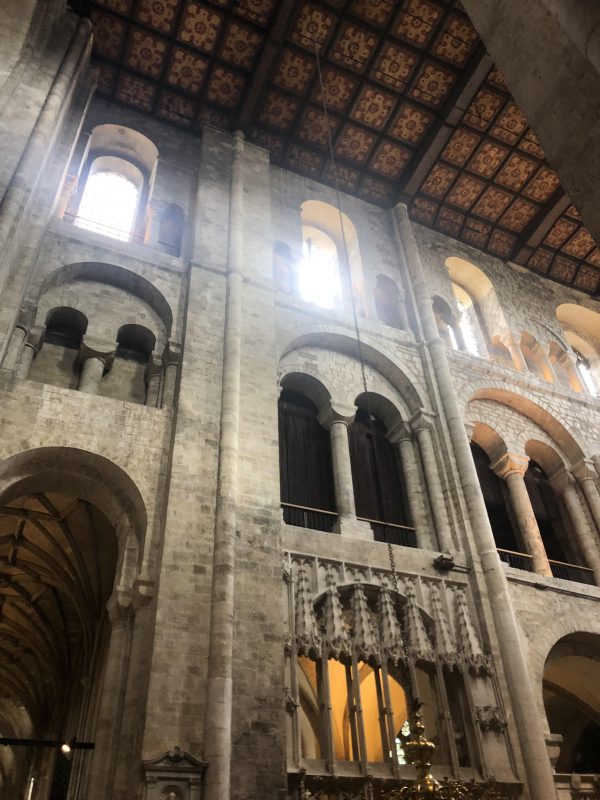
[{"xmin": 490, "ymin": 453, "xmax": 552, "ymax": 575}]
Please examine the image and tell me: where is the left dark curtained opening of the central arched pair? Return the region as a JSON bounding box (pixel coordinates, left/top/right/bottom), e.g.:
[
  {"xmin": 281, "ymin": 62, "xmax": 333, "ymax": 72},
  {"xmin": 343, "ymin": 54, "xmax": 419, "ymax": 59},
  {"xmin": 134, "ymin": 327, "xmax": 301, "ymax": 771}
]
[{"xmin": 279, "ymin": 389, "xmax": 337, "ymax": 531}]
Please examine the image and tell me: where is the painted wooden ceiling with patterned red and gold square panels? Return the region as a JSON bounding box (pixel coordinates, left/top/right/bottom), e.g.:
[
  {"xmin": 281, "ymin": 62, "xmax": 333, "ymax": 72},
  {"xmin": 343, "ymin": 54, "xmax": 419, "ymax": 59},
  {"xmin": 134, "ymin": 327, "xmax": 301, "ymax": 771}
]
[{"xmin": 74, "ymin": 0, "xmax": 600, "ymax": 293}]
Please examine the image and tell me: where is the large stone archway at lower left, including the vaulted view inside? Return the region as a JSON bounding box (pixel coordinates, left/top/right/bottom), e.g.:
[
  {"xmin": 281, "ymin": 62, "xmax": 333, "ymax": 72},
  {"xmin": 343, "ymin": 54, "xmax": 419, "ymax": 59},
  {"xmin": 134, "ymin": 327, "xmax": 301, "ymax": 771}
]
[{"xmin": 0, "ymin": 448, "xmax": 145, "ymax": 800}]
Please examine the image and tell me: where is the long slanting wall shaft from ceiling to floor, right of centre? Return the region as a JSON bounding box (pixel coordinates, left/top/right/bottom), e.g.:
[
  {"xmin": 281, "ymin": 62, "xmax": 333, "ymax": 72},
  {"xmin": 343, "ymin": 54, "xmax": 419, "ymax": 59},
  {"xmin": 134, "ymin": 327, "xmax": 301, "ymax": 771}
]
[{"xmin": 393, "ymin": 203, "xmax": 556, "ymax": 800}]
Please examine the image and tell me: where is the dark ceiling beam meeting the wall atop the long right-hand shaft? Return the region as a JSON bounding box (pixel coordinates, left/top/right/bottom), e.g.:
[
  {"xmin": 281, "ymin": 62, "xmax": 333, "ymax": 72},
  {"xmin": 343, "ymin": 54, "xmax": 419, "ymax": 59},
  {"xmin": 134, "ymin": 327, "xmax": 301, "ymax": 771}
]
[{"xmin": 400, "ymin": 45, "xmax": 493, "ymax": 202}]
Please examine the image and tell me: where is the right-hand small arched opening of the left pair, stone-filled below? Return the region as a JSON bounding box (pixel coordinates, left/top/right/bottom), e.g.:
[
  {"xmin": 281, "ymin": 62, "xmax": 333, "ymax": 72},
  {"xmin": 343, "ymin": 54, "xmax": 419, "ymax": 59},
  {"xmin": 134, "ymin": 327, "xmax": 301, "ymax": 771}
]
[{"xmin": 98, "ymin": 325, "xmax": 156, "ymax": 403}]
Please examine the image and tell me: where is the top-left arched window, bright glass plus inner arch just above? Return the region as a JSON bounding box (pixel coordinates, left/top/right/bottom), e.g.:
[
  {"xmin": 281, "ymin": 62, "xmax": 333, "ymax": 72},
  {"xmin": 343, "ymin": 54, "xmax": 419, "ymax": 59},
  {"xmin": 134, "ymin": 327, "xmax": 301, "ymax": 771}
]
[{"xmin": 75, "ymin": 157, "xmax": 143, "ymax": 241}]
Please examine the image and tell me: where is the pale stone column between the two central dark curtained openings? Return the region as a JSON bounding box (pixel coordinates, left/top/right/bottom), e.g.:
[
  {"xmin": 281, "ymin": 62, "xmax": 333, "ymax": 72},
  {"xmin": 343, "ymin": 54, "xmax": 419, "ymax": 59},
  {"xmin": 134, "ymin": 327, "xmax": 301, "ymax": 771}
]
[{"xmin": 319, "ymin": 404, "xmax": 373, "ymax": 540}]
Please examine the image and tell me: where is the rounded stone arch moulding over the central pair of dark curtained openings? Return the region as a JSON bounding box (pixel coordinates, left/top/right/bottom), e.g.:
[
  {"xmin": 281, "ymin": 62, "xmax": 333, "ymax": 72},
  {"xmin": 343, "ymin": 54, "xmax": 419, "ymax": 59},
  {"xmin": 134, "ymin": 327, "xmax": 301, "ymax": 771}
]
[{"xmin": 280, "ymin": 327, "xmax": 426, "ymax": 415}]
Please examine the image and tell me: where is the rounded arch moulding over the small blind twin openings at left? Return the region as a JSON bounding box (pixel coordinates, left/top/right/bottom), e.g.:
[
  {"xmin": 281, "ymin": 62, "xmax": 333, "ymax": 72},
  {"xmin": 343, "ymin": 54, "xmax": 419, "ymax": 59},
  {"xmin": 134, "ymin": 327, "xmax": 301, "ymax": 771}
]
[{"xmin": 36, "ymin": 261, "xmax": 173, "ymax": 336}]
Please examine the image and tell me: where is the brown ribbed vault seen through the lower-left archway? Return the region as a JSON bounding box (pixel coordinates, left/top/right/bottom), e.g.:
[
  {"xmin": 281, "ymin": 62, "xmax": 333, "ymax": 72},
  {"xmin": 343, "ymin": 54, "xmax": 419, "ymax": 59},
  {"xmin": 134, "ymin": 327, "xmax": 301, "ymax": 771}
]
[{"xmin": 0, "ymin": 492, "xmax": 117, "ymax": 796}]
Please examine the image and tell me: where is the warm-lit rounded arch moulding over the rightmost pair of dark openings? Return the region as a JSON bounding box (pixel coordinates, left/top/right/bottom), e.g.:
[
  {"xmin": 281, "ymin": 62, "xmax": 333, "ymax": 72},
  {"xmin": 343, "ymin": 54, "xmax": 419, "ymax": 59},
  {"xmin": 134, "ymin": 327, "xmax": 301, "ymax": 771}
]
[{"xmin": 465, "ymin": 382, "xmax": 586, "ymax": 464}]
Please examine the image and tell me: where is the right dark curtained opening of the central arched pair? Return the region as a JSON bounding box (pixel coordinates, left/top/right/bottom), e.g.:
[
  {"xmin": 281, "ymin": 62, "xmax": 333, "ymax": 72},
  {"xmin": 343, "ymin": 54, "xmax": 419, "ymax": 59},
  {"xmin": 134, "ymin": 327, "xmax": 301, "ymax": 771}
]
[{"xmin": 348, "ymin": 408, "xmax": 416, "ymax": 547}]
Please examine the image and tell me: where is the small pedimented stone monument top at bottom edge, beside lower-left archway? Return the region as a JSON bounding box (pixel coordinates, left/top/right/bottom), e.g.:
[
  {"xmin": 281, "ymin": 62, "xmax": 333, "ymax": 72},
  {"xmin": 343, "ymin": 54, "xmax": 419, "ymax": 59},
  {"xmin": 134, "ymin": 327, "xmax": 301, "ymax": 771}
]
[{"xmin": 142, "ymin": 747, "xmax": 208, "ymax": 800}]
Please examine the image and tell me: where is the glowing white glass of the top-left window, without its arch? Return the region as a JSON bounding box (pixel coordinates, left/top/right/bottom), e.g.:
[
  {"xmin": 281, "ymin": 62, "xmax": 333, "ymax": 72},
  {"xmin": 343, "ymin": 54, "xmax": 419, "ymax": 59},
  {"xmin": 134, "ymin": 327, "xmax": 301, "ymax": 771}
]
[{"xmin": 75, "ymin": 172, "xmax": 138, "ymax": 242}]
